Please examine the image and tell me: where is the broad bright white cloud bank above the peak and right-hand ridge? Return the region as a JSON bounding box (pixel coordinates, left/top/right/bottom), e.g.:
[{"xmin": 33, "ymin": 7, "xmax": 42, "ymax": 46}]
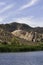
[{"xmin": 9, "ymin": 16, "xmax": 43, "ymax": 27}]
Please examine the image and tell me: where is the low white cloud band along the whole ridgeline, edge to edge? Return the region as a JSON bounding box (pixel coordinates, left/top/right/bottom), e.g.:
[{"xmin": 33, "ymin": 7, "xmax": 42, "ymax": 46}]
[{"xmin": 0, "ymin": 16, "xmax": 43, "ymax": 27}]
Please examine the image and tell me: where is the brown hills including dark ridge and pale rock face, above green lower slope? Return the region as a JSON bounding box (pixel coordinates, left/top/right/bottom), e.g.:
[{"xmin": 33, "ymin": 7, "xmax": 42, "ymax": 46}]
[{"xmin": 0, "ymin": 22, "xmax": 43, "ymax": 42}]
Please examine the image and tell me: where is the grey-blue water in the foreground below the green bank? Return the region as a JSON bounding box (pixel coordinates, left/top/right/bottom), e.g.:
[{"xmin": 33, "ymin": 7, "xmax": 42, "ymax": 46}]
[{"xmin": 0, "ymin": 51, "xmax": 43, "ymax": 65}]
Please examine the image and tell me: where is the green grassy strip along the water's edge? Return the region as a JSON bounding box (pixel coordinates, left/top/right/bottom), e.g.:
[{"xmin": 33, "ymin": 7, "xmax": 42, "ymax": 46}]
[{"xmin": 0, "ymin": 42, "xmax": 43, "ymax": 52}]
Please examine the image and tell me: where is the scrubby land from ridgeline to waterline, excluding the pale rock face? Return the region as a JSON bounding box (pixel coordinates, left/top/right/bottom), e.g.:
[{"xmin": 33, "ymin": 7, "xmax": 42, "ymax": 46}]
[{"xmin": 0, "ymin": 23, "xmax": 43, "ymax": 52}]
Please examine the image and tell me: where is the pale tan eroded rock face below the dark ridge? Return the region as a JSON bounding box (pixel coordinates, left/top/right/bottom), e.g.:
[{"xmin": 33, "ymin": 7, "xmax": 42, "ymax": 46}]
[{"xmin": 12, "ymin": 30, "xmax": 43, "ymax": 42}]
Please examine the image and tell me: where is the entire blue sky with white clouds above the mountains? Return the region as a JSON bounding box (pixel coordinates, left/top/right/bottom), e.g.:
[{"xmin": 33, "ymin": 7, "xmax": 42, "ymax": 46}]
[{"xmin": 0, "ymin": 0, "xmax": 43, "ymax": 27}]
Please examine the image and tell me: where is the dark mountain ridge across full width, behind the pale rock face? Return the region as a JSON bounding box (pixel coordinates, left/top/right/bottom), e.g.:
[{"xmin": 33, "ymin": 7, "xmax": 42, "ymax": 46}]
[{"xmin": 0, "ymin": 22, "xmax": 43, "ymax": 33}]
